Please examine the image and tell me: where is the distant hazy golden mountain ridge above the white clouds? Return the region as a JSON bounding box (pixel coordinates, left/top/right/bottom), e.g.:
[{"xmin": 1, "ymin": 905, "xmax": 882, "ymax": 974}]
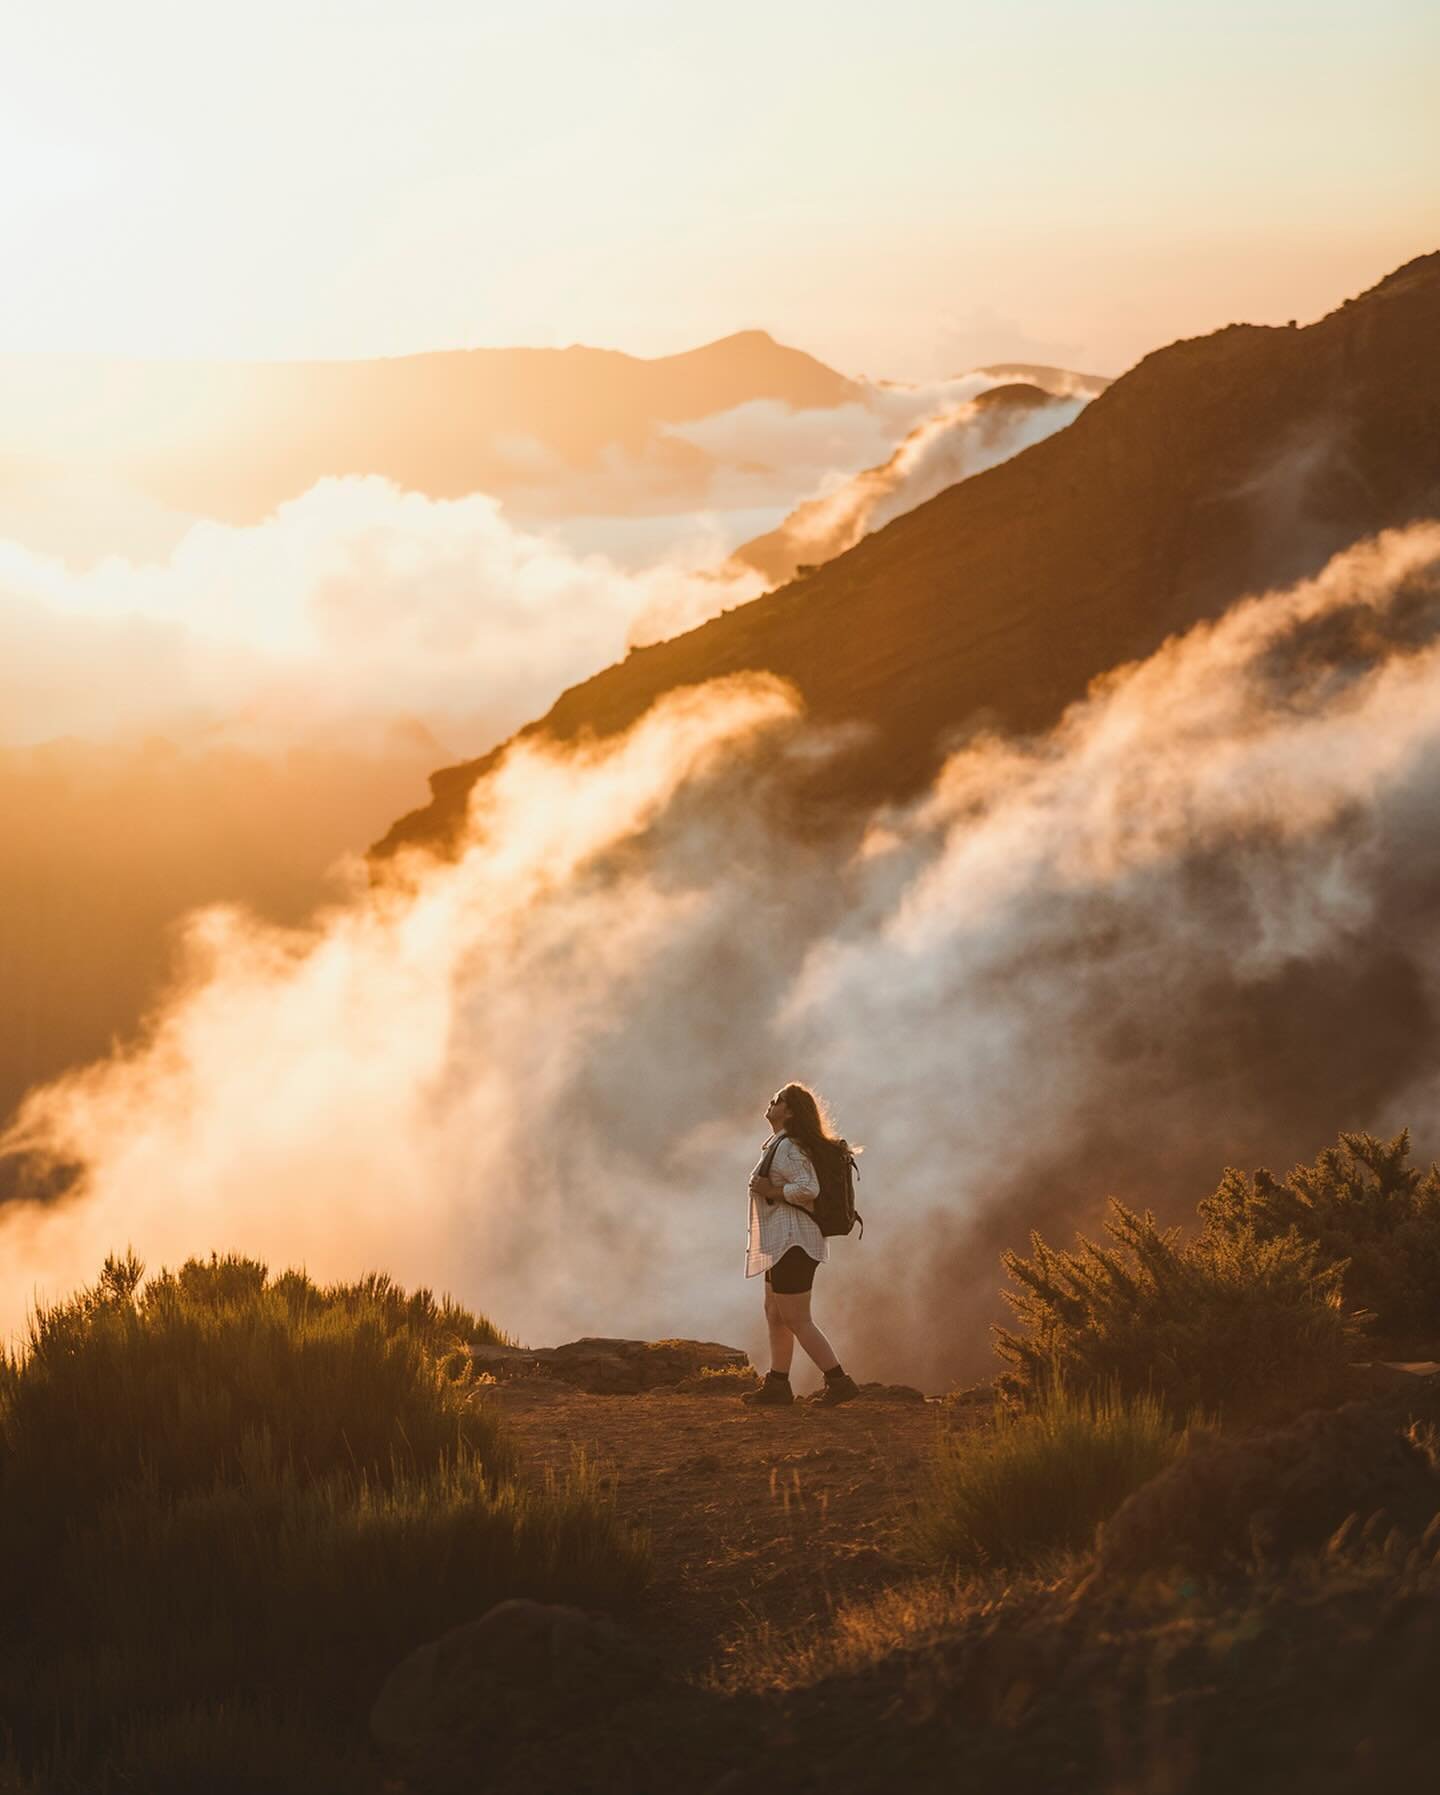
[{"xmin": 0, "ymin": 330, "xmax": 860, "ymax": 524}]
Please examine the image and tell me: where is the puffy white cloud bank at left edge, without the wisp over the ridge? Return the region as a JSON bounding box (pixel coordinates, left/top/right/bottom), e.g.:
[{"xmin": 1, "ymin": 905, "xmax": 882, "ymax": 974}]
[{"xmin": 0, "ymin": 476, "xmax": 760, "ymax": 752}]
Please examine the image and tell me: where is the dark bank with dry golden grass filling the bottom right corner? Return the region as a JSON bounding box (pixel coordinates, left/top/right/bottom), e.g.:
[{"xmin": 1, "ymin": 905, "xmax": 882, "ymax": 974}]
[{"xmin": 707, "ymin": 1522, "xmax": 1440, "ymax": 1795}]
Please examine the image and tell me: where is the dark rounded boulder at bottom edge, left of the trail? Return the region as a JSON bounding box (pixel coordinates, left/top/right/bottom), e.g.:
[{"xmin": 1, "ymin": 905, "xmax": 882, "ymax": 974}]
[{"xmin": 370, "ymin": 1599, "xmax": 661, "ymax": 1791}]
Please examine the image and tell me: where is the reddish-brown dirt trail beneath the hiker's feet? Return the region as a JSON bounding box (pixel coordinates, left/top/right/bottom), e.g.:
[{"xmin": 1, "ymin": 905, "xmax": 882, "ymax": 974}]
[{"xmin": 487, "ymin": 1379, "xmax": 948, "ymax": 1669}]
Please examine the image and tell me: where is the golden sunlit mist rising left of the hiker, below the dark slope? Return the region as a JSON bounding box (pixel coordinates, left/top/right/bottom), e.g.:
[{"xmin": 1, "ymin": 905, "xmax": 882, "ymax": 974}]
[{"xmin": 0, "ymin": 677, "xmax": 807, "ymax": 1325}]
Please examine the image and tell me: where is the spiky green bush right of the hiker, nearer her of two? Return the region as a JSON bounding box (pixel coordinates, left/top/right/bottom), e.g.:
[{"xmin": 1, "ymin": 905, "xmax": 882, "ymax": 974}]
[{"xmin": 997, "ymin": 1199, "xmax": 1359, "ymax": 1420}]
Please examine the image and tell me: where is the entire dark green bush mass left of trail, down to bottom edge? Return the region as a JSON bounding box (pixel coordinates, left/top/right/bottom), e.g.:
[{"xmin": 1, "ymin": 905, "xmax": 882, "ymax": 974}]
[{"xmin": 0, "ymin": 1258, "xmax": 648, "ymax": 1795}]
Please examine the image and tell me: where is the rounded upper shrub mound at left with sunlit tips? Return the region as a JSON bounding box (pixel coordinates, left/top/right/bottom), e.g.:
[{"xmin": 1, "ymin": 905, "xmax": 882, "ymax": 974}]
[{"xmin": 0, "ymin": 1257, "xmax": 512, "ymax": 1626}]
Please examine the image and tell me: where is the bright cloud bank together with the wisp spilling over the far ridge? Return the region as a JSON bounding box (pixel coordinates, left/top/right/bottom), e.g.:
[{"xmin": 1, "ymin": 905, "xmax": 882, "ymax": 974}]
[{"xmin": 0, "ymin": 377, "xmax": 1062, "ymax": 756}]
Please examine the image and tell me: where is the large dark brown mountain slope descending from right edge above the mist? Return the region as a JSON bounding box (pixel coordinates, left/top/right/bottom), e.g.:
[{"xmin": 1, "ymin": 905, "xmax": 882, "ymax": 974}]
[{"xmin": 377, "ymin": 253, "xmax": 1440, "ymax": 854}]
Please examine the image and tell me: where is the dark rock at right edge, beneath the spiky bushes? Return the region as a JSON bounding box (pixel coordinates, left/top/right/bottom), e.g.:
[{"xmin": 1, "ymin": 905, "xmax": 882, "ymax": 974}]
[{"xmin": 1097, "ymin": 1402, "xmax": 1440, "ymax": 1574}]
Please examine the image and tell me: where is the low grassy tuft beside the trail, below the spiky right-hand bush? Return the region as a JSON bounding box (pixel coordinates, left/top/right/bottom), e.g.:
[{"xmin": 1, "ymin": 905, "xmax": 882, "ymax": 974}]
[{"xmin": 909, "ymin": 1382, "xmax": 1185, "ymax": 1571}]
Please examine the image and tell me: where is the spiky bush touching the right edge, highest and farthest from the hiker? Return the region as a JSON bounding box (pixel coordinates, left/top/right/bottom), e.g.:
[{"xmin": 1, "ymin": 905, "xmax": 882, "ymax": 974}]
[{"xmin": 1199, "ymin": 1129, "xmax": 1440, "ymax": 1346}]
